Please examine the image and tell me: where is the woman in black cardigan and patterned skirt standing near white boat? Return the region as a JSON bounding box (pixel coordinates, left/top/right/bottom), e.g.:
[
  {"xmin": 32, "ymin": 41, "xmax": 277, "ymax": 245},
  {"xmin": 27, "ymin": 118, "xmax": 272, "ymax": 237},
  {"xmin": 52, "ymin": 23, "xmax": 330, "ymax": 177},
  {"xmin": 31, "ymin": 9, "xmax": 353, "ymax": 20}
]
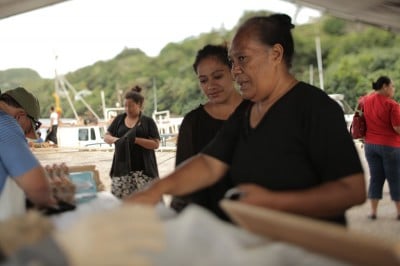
[{"xmin": 104, "ymin": 86, "xmax": 160, "ymax": 198}]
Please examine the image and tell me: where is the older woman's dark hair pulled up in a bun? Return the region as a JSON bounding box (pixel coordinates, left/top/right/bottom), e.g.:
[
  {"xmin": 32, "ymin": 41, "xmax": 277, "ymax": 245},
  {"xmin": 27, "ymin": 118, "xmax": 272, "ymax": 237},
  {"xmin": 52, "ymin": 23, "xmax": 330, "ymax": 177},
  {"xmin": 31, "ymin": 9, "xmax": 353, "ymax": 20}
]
[{"xmin": 238, "ymin": 14, "xmax": 294, "ymax": 68}]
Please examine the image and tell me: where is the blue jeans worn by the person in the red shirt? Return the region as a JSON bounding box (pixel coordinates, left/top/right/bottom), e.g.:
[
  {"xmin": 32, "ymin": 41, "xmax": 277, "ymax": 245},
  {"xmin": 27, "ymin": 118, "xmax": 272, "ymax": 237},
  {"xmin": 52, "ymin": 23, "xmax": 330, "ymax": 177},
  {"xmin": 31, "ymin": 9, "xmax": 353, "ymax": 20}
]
[{"xmin": 364, "ymin": 143, "xmax": 400, "ymax": 201}]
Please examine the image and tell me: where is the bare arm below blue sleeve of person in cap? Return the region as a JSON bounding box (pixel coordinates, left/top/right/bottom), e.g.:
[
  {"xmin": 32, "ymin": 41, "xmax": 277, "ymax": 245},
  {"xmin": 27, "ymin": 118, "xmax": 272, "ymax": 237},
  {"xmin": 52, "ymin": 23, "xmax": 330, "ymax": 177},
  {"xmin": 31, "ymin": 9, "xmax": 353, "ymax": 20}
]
[{"xmin": 15, "ymin": 166, "xmax": 57, "ymax": 207}]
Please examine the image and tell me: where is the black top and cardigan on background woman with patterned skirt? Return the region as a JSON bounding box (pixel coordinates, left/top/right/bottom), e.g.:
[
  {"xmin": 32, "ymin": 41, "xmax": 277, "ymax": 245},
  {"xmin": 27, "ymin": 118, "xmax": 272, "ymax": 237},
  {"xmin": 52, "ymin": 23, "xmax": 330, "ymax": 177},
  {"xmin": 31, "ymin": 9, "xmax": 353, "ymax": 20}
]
[{"xmin": 107, "ymin": 113, "xmax": 160, "ymax": 177}]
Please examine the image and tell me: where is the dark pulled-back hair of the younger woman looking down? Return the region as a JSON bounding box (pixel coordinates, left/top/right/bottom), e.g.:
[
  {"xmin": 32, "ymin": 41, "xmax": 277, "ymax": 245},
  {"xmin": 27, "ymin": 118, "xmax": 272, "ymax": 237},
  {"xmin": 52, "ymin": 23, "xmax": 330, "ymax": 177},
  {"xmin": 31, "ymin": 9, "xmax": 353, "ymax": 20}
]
[{"xmin": 193, "ymin": 44, "xmax": 232, "ymax": 74}]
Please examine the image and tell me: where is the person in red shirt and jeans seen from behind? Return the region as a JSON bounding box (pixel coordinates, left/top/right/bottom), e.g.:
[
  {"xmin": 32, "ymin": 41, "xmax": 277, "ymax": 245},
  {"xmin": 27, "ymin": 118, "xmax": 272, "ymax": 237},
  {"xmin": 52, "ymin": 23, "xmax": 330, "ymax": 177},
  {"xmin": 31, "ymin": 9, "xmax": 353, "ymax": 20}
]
[{"xmin": 362, "ymin": 76, "xmax": 400, "ymax": 220}]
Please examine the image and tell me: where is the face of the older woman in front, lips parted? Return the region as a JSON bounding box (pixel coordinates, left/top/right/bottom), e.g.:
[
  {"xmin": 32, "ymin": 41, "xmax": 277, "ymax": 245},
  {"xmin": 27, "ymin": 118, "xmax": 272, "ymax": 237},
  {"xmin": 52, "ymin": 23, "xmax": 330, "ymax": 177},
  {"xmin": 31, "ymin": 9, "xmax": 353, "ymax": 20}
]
[{"xmin": 229, "ymin": 31, "xmax": 279, "ymax": 102}]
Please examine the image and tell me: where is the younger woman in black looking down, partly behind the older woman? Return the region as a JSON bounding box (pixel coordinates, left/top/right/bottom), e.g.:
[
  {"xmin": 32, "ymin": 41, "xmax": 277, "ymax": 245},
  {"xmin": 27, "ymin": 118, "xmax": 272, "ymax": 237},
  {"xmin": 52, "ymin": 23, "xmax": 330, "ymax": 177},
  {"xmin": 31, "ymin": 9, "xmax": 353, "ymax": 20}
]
[{"xmin": 171, "ymin": 45, "xmax": 242, "ymax": 219}]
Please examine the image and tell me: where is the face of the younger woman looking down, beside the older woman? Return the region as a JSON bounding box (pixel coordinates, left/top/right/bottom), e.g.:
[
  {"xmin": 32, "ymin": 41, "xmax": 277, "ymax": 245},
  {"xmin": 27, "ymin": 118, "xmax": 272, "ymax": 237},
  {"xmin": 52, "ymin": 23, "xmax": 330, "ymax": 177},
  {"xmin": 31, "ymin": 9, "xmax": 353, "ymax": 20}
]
[{"xmin": 197, "ymin": 57, "xmax": 235, "ymax": 104}]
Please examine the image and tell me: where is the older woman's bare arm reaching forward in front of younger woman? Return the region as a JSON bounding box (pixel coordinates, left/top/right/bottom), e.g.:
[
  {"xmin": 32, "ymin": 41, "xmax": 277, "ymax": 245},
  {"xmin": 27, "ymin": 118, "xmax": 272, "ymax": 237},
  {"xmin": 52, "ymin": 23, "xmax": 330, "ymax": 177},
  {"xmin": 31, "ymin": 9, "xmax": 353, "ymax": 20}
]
[{"xmin": 126, "ymin": 154, "xmax": 228, "ymax": 204}]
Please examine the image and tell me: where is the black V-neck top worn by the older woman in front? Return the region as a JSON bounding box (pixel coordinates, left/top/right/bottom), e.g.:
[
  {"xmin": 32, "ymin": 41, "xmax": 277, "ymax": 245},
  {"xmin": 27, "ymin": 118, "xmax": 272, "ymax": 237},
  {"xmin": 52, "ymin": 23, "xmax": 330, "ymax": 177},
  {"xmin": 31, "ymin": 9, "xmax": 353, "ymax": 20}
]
[{"xmin": 202, "ymin": 82, "xmax": 363, "ymax": 224}]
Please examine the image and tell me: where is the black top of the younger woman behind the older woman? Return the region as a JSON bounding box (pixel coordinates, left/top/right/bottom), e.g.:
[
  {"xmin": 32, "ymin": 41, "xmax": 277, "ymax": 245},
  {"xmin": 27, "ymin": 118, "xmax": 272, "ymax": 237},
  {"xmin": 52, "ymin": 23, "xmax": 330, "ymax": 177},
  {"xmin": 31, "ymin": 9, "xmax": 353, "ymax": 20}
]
[{"xmin": 171, "ymin": 105, "xmax": 232, "ymax": 220}]
